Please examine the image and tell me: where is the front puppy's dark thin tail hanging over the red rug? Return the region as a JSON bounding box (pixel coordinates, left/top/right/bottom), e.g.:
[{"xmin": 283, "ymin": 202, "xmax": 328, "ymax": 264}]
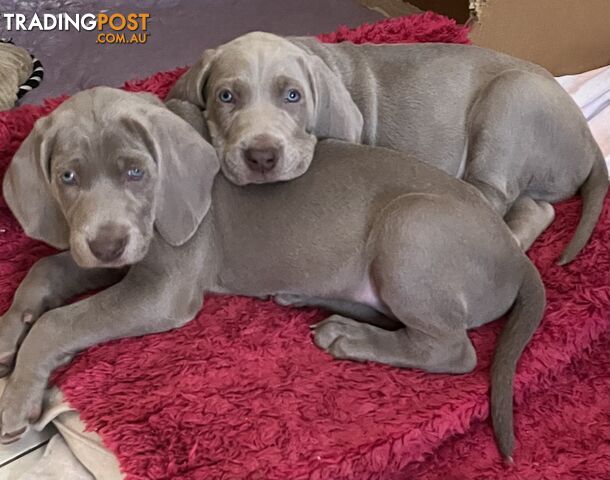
[{"xmin": 491, "ymin": 261, "xmax": 546, "ymax": 463}]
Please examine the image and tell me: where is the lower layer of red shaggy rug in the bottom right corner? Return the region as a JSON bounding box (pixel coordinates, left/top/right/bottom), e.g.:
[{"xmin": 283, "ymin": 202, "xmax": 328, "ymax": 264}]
[{"xmin": 396, "ymin": 332, "xmax": 610, "ymax": 480}]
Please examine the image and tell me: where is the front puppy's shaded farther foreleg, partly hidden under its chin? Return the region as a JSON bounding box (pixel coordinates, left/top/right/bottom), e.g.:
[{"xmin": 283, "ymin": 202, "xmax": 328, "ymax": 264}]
[{"xmin": 0, "ymin": 252, "xmax": 125, "ymax": 377}]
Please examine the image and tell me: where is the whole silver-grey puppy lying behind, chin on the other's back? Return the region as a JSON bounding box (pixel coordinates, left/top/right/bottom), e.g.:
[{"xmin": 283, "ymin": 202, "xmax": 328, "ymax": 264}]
[{"xmin": 168, "ymin": 32, "xmax": 608, "ymax": 264}]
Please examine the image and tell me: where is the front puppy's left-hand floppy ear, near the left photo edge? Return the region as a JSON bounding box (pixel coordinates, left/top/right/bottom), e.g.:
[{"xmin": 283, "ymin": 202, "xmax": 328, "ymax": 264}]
[{"xmin": 2, "ymin": 114, "xmax": 70, "ymax": 250}]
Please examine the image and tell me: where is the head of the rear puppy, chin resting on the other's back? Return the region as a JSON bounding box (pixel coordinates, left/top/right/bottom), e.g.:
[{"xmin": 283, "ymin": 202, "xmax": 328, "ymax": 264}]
[{"xmin": 168, "ymin": 32, "xmax": 363, "ymax": 185}]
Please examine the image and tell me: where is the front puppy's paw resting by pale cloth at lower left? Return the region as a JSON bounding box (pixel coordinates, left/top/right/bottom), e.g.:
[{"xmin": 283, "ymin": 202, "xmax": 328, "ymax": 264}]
[{"xmin": 0, "ymin": 377, "xmax": 44, "ymax": 444}]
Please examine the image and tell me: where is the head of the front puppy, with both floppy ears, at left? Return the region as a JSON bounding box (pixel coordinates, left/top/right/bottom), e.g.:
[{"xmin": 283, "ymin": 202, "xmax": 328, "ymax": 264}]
[{"xmin": 3, "ymin": 87, "xmax": 219, "ymax": 267}]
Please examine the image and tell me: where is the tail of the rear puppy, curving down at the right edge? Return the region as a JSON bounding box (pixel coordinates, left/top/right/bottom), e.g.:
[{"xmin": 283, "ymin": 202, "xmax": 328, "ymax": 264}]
[{"xmin": 557, "ymin": 152, "xmax": 608, "ymax": 265}]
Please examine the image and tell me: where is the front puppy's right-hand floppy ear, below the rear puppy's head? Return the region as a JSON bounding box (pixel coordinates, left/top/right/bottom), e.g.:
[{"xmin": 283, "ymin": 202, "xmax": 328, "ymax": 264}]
[{"xmin": 128, "ymin": 106, "xmax": 220, "ymax": 246}]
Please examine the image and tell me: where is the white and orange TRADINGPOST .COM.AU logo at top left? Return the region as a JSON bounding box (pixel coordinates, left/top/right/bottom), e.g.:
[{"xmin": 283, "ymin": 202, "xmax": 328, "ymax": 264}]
[{"xmin": 1, "ymin": 12, "xmax": 150, "ymax": 44}]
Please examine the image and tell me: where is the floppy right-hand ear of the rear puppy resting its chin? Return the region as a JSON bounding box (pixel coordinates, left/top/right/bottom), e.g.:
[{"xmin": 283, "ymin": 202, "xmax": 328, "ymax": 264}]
[{"xmin": 307, "ymin": 55, "xmax": 364, "ymax": 143}]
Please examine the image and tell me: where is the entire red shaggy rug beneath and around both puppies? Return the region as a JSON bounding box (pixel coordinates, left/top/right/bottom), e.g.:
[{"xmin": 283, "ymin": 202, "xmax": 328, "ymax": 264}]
[{"xmin": 0, "ymin": 14, "xmax": 610, "ymax": 480}]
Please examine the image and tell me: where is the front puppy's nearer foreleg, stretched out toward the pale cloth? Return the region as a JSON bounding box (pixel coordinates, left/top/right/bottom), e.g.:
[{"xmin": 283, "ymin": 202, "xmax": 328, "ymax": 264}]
[{"xmin": 0, "ymin": 264, "xmax": 198, "ymax": 443}]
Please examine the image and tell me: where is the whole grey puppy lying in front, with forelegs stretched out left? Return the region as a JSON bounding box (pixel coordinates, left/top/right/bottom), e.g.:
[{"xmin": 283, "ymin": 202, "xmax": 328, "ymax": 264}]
[{"xmin": 0, "ymin": 87, "xmax": 545, "ymax": 457}]
